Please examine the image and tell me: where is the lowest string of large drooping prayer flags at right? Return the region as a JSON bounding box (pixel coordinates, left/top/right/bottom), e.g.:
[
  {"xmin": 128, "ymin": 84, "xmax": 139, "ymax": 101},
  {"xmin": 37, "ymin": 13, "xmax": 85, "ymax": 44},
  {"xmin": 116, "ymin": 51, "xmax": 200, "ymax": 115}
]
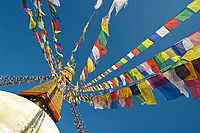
[{"xmin": 90, "ymin": 55, "xmax": 200, "ymax": 109}]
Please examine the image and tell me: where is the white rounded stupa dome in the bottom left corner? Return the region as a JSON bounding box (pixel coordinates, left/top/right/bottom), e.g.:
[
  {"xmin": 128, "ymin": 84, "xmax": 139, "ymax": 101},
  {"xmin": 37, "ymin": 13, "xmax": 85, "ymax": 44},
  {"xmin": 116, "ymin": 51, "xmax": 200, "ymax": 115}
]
[{"xmin": 0, "ymin": 91, "xmax": 60, "ymax": 133}]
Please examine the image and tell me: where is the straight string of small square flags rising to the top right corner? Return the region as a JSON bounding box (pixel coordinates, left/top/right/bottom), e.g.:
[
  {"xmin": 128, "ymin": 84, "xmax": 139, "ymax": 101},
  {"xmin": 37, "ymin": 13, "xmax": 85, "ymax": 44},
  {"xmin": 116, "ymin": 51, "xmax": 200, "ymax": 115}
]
[{"xmin": 85, "ymin": 0, "xmax": 200, "ymax": 87}]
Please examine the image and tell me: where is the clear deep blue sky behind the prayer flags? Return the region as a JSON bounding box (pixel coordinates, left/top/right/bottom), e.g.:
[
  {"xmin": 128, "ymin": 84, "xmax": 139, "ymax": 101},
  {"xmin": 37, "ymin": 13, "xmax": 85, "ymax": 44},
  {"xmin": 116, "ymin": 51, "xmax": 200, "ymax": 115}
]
[{"xmin": 0, "ymin": 0, "xmax": 200, "ymax": 133}]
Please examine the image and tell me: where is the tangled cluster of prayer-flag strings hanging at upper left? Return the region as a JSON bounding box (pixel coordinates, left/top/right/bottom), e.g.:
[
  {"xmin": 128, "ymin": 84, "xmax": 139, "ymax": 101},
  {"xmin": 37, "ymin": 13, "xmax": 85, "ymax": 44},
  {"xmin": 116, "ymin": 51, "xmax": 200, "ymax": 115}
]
[{"xmin": 22, "ymin": 0, "xmax": 74, "ymax": 90}]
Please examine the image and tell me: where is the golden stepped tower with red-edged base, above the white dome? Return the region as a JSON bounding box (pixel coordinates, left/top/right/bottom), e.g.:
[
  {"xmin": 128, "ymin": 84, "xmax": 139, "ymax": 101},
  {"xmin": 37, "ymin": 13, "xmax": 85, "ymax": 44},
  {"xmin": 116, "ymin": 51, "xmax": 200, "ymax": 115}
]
[{"xmin": 19, "ymin": 80, "xmax": 63, "ymax": 122}]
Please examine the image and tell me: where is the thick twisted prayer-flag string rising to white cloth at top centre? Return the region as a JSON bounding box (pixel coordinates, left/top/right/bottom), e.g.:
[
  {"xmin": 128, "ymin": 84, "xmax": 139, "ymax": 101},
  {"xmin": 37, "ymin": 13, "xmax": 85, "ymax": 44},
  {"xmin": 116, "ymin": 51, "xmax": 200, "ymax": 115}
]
[{"xmin": 75, "ymin": 0, "xmax": 128, "ymax": 85}]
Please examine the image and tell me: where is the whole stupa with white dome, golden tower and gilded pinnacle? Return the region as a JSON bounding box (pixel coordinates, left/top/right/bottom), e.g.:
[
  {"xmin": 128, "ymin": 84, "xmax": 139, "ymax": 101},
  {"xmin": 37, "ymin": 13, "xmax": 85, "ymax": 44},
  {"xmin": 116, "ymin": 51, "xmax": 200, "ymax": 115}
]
[{"xmin": 0, "ymin": 65, "xmax": 75, "ymax": 133}]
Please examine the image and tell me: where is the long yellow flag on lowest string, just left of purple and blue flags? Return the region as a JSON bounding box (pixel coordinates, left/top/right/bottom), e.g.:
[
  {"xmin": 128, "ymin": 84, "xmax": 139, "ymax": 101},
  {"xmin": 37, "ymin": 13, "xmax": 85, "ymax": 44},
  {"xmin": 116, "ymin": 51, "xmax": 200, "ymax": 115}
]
[{"xmin": 137, "ymin": 80, "xmax": 157, "ymax": 105}]
